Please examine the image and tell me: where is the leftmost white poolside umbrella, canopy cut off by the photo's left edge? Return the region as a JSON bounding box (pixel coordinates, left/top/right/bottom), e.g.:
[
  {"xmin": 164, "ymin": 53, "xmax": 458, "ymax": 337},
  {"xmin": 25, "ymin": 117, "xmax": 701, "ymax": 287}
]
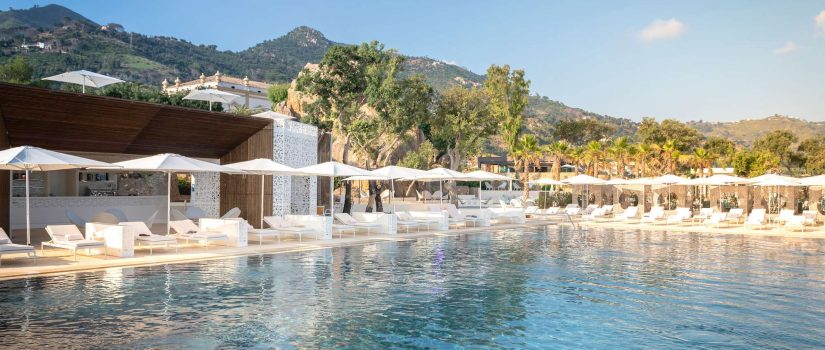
[{"xmin": 0, "ymin": 146, "xmax": 113, "ymax": 244}]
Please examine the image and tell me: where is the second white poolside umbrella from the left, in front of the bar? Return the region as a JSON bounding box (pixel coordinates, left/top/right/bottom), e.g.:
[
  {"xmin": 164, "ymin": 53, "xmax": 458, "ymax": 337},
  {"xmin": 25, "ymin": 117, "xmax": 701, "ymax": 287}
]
[{"xmin": 115, "ymin": 153, "xmax": 243, "ymax": 235}]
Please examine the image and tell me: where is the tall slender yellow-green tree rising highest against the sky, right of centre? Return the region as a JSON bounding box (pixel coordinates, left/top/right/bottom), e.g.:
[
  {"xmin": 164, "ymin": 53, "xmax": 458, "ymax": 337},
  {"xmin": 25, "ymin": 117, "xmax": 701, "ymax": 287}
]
[{"xmin": 484, "ymin": 65, "xmax": 530, "ymax": 165}]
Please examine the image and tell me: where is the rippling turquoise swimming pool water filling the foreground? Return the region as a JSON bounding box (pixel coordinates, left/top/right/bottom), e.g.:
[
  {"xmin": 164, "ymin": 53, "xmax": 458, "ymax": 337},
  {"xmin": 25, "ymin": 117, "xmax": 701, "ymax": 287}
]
[{"xmin": 0, "ymin": 226, "xmax": 825, "ymax": 349}]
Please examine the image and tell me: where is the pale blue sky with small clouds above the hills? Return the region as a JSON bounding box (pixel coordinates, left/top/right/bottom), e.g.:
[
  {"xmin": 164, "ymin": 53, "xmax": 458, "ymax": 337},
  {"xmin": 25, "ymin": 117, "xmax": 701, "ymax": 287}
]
[{"xmin": 9, "ymin": 0, "xmax": 825, "ymax": 121}]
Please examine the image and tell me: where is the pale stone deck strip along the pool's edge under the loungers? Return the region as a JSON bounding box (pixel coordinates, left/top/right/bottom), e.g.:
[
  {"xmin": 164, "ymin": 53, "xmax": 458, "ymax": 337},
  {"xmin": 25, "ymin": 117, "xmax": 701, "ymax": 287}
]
[{"xmin": 0, "ymin": 219, "xmax": 825, "ymax": 280}]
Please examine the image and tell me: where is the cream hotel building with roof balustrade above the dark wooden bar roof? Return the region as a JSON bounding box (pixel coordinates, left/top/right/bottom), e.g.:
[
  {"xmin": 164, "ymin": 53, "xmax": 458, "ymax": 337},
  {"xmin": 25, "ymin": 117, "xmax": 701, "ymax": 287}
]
[{"xmin": 161, "ymin": 71, "xmax": 272, "ymax": 111}]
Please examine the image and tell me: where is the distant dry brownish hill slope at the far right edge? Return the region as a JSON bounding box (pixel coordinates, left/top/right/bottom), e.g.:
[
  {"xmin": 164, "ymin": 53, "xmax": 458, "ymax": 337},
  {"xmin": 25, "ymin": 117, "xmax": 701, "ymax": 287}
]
[{"xmin": 688, "ymin": 115, "xmax": 825, "ymax": 146}]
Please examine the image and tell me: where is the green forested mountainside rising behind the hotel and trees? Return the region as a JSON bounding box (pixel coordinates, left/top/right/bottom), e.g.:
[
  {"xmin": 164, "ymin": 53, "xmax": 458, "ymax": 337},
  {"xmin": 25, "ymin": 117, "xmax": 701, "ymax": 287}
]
[{"xmin": 0, "ymin": 5, "xmax": 635, "ymax": 156}]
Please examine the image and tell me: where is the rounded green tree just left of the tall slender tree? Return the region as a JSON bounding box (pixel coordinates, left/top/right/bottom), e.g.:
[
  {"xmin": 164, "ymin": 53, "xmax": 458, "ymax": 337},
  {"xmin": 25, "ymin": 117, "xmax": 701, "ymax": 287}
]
[{"xmin": 430, "ymin": 86, "xmax": 500, "ymax": 170}]
